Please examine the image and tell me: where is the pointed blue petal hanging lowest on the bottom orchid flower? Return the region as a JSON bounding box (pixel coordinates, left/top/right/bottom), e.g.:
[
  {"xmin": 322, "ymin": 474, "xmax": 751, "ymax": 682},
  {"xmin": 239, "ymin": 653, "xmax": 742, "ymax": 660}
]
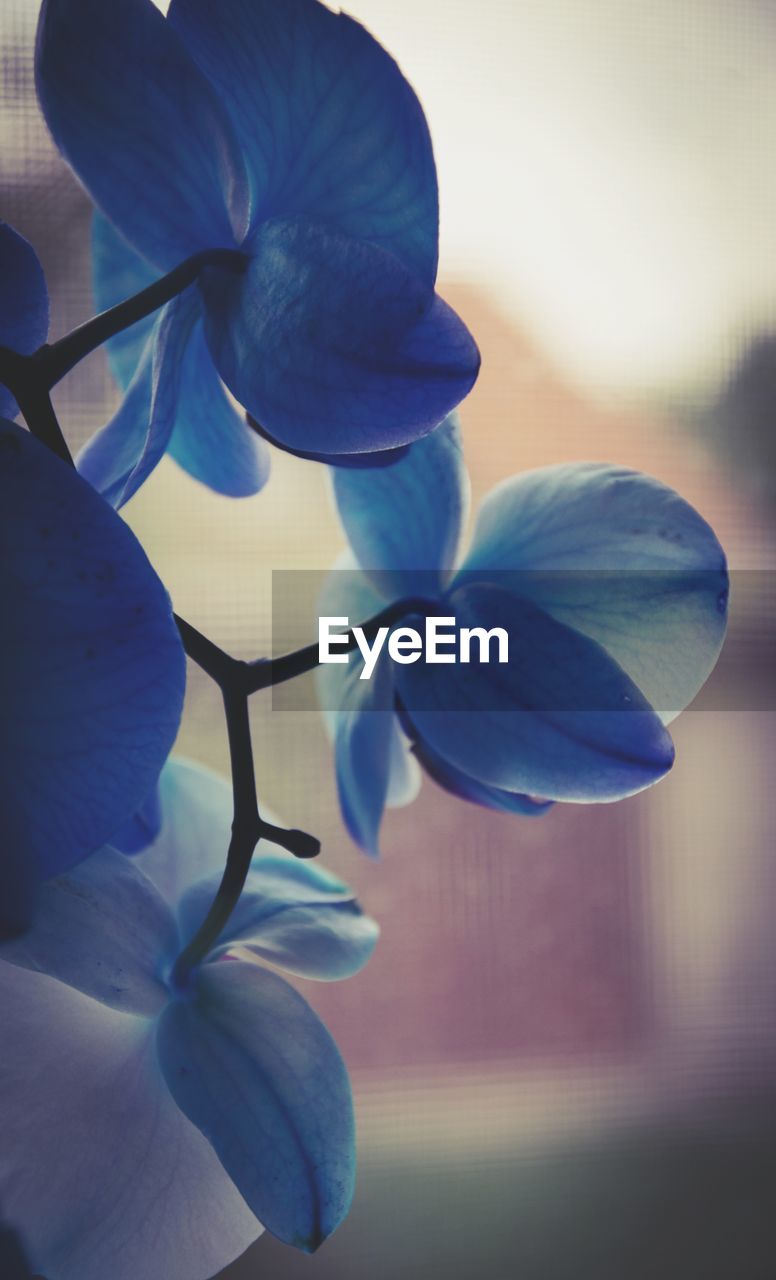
[{"xmin": 156, "ymin": 960, "xmax": 353, "ymax": 1251}]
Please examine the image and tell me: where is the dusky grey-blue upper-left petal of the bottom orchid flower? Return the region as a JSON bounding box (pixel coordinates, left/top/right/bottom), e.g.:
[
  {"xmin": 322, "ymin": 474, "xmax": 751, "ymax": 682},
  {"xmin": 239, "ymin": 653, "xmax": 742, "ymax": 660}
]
[{"xmin": 0, "ymin": 845, "xmax": 178, "ymax": 1015}]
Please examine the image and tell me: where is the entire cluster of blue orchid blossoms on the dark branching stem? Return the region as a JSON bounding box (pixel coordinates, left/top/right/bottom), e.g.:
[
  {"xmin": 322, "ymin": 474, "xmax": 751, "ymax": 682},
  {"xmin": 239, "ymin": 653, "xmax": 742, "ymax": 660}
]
[{"xmin": 0, "ymin": 0, "xmax": 727, "ymax": 1280}]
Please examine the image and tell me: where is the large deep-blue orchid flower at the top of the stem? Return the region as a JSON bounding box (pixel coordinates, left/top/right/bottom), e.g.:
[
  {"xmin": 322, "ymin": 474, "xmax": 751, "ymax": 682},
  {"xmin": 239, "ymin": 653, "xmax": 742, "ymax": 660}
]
[{"xmin": 36, "ymin": 0, "xmax": 479, "ymax": 504}]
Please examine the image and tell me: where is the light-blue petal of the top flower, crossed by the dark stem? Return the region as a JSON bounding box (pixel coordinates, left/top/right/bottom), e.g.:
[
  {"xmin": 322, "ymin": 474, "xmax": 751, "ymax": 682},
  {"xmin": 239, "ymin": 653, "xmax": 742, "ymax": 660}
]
[{"xmin": 92, "ymin": 210, "xmax": 159, "ymax": 392}]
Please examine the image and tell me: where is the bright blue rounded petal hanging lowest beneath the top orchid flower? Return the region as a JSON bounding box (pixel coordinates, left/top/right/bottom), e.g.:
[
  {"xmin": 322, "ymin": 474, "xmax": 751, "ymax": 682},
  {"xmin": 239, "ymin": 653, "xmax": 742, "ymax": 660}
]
[{"xmin": 169, "ymin": 319, "xmax": 270, "ymax": 498}]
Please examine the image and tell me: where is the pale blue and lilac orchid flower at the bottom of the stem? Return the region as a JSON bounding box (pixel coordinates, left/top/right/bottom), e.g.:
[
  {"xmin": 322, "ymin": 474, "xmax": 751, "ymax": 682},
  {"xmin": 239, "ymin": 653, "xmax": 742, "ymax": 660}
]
[{"xmin": 0, "ymin": 762, "xmax": 378, "ymax": 1280}]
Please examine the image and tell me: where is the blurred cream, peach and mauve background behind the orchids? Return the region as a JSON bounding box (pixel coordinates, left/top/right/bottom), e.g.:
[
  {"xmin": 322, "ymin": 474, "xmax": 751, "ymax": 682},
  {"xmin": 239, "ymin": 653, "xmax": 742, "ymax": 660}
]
[{"xmin": 0, "ymin": 0, "xmax": 776, "ymax": 1280}]
